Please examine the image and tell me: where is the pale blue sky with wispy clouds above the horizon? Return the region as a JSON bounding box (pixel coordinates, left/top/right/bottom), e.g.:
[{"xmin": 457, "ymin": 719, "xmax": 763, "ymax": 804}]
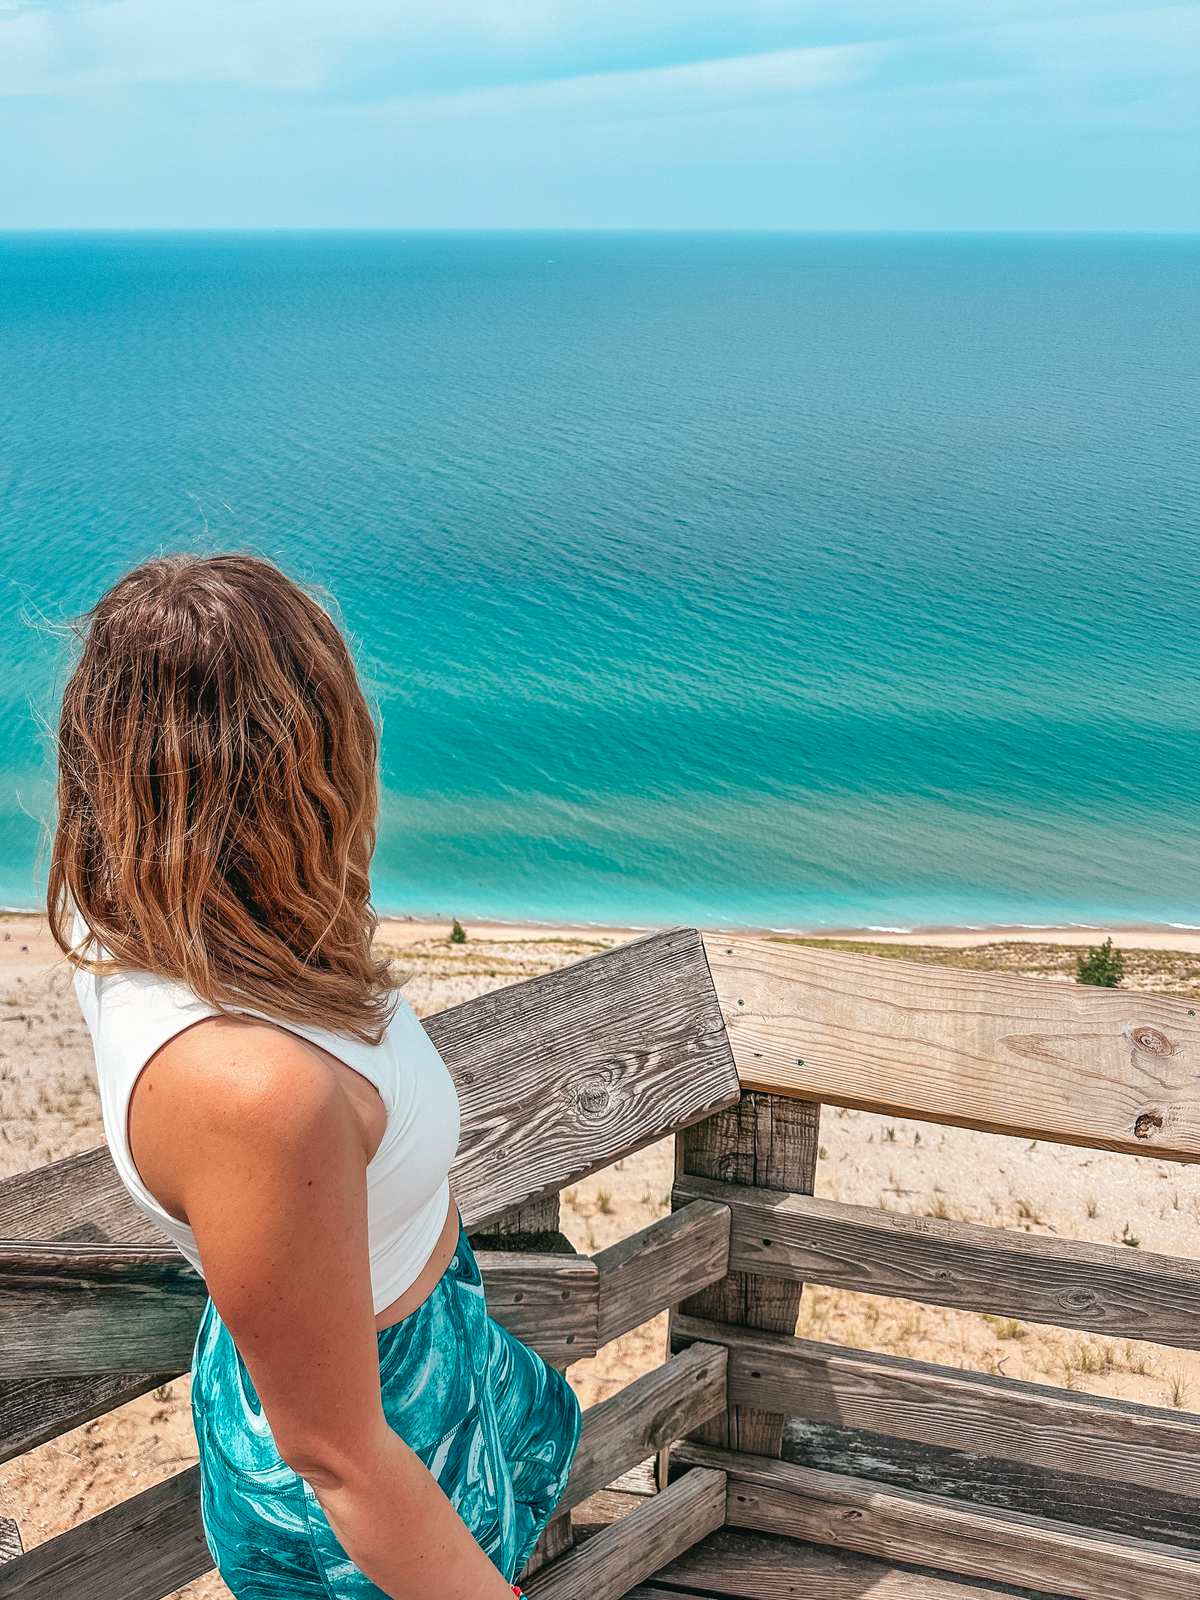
[{"xmin": 0, "ymin": 0, "xmax": 1200, "ymax": 229}]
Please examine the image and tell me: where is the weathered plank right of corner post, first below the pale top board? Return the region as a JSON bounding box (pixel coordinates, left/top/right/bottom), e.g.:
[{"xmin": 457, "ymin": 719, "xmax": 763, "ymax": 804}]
[{"xmin": 675, "ymin": 1178, "xmax": 1200, "ymax": 1349}]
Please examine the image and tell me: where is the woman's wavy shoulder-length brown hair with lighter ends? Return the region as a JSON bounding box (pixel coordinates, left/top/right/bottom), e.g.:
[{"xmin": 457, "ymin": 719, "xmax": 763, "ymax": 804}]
[{"xmin": 46, "ymin": 555, "xmax": 392, "ymax": 1042}]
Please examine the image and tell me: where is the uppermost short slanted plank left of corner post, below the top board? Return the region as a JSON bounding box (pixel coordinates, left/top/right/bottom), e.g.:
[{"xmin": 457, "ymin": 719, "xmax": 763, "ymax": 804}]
[{"xmin": 594, "ymin": 1202, "xmax": 730, "ymax": 1344}]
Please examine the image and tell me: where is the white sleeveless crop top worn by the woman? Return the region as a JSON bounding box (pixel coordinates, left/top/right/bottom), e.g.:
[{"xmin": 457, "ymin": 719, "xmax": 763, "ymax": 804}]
[{"xmin": 75, "ymin": 917, "xmax": 459, "ymax": 1312}]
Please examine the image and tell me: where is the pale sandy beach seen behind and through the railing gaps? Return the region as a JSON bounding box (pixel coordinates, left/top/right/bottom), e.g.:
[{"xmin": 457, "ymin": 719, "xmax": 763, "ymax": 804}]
[{"xmin": 0, "ymin": 912, "xmax": 1200, "ymax": 1600}]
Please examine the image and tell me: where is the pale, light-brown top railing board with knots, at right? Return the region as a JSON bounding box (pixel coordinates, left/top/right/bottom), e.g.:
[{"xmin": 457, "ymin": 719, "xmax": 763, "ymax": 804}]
[{"xmin": 706, "ymin": 934, "xmax": 1200, "ymax": 1162}]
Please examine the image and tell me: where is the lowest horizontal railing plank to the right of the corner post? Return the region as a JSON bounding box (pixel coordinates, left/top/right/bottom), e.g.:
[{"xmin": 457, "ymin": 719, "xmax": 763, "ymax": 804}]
[{"xmin": 678, "ymin": 1443, "xmax": 1200, "ymax": 1600}]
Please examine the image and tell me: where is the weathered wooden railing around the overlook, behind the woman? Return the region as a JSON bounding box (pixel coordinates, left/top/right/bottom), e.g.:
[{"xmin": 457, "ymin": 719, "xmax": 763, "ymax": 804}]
[{"xmin": 0, "ymin": 930, "xmax": 1200, "ymax": 1600}]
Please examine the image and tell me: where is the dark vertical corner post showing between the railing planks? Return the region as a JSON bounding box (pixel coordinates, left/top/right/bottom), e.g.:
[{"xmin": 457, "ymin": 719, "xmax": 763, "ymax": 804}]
[{"xmin": 672, "ymin": 1094, "xmax": 821, "ymax": 1456}]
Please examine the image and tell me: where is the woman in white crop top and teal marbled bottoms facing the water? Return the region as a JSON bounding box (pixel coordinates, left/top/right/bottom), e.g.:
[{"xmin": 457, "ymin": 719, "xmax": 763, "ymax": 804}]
[{"xmin": 50, "ymin": 555, "xmax": 579, "ymax": 1600}]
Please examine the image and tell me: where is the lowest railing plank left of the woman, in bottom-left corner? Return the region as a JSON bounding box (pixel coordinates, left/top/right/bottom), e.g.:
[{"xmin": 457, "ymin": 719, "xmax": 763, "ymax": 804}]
[{"xmin": 0, "ymin": 1467, "xmax": 213, "ymax": 1600}]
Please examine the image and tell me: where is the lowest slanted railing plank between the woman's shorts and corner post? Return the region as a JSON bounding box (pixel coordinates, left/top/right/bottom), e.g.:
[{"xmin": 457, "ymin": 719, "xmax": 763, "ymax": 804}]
[{"xmin": 528, "ymin": 1470, "xmax": 725, "ymax": 1600}]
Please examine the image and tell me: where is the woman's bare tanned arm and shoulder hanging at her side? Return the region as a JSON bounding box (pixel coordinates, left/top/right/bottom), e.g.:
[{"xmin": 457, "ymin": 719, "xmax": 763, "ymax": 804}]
[{"xmin": 130, "ymin": 1019, "xmax": 512, "ymax": 1600}]
